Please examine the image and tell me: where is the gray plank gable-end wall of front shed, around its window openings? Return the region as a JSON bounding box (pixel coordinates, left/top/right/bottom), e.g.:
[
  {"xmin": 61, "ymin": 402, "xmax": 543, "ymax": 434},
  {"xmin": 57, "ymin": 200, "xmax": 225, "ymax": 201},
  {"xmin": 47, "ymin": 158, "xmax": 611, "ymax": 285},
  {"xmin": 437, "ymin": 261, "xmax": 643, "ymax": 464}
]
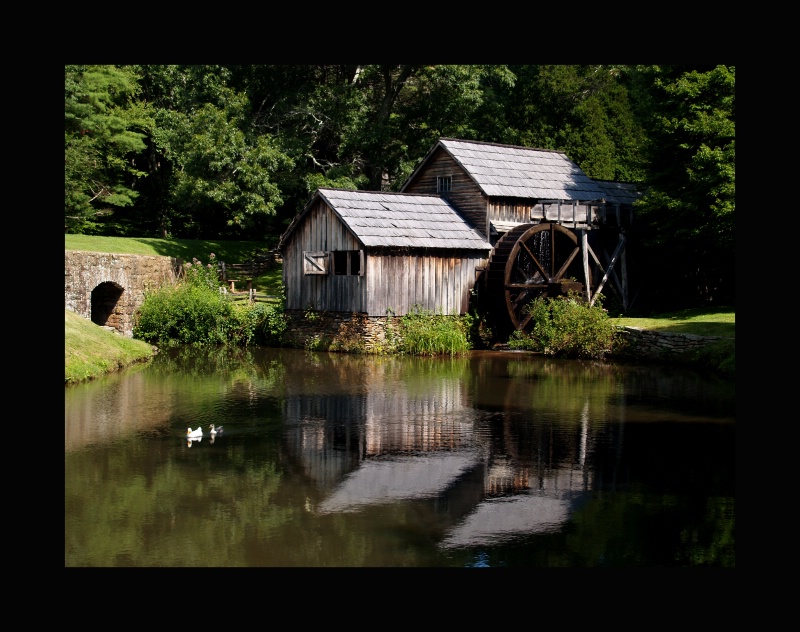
[{"xmin": 283, "ymin": 201, "xmax": 367, "ymax": 312}]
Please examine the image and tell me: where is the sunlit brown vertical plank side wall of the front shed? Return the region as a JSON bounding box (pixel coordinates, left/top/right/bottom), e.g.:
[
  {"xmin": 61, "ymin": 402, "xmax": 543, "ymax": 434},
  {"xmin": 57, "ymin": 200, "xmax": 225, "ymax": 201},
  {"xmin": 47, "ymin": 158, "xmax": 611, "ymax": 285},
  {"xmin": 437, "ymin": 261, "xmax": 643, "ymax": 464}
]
[{"xmin": 366, "ymin": 251, "xmax": 487, "ymax": 316}]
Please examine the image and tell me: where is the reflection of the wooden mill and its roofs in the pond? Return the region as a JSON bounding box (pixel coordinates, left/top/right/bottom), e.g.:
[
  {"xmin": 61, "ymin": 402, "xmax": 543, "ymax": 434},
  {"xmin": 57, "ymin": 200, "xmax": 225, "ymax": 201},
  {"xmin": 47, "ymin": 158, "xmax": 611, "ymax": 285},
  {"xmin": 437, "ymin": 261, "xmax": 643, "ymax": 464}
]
[{"xmin": 285, "ymin": 362, "xmax": 591, "ymax": 546}]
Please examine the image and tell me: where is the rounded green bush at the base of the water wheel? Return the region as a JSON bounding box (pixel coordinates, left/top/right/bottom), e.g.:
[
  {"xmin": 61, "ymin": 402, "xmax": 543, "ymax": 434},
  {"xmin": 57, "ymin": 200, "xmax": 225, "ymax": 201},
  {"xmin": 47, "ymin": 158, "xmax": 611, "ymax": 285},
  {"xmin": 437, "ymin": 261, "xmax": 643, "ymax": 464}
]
[{"xmin": 508, "ymin": 292, "xmax": 616, "ymax": 359}]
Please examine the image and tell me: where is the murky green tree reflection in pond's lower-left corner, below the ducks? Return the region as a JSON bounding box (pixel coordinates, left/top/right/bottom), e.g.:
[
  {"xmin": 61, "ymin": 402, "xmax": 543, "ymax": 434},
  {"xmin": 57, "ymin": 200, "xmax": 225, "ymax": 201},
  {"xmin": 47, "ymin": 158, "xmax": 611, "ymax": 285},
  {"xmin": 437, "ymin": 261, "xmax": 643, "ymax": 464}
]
[{"xmin": 64, "ymin": 432, "xmax": 293, "ymax": 567}]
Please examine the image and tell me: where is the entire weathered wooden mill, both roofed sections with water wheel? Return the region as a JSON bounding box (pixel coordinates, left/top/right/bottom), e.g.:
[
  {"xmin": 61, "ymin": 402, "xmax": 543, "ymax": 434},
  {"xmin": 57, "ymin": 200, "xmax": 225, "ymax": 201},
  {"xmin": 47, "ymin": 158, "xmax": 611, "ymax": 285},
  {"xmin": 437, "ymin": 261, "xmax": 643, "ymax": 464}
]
[{"xmin": 279, "ymin": 138, "xmax": 638, "ymax": 346}]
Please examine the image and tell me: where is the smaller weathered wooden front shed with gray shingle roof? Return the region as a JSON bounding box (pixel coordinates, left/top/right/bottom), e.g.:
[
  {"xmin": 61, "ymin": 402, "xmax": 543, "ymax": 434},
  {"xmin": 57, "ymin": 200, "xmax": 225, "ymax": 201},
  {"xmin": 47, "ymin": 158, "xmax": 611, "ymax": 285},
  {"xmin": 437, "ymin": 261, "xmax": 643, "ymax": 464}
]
[{"xmin": 278, "ymin": 188, "xmax": 492, "ymax": 317}]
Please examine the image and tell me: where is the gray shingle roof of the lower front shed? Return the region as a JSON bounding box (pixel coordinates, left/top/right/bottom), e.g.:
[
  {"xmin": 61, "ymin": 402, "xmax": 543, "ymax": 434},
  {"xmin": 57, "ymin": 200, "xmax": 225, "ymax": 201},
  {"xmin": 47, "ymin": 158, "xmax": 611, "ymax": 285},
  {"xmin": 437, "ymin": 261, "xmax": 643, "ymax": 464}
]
[{"xmin": 310, "ymin": 189, "xmax": 492, "ymax": 250}]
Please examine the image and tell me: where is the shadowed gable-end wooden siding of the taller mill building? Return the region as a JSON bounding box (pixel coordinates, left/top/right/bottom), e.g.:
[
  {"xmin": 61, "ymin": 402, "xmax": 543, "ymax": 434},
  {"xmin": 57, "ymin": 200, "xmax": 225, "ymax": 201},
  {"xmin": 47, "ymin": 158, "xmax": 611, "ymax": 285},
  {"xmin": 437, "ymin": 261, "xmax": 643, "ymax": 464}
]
[{"xmin": 403, "ymin": 148, "xmax": 489, "ymax": 239}]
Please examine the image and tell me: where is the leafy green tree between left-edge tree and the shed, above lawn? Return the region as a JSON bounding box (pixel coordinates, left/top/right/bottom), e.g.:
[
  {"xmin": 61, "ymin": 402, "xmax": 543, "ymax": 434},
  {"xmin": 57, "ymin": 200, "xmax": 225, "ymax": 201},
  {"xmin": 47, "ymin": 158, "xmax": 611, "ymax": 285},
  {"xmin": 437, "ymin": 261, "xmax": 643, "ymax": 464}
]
[{"xmin": 126, "ymin": 66, "xmax": 293, "ymax": 239}]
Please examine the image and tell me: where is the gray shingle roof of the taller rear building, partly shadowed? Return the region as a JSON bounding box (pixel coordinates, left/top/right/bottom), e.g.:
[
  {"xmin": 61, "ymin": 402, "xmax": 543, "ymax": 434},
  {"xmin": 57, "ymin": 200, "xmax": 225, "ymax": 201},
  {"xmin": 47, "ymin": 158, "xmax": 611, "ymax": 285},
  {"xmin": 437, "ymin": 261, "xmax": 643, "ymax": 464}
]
[{"xmin": 429, "ymin": 138, "xmax": 604, "ymax": 201}]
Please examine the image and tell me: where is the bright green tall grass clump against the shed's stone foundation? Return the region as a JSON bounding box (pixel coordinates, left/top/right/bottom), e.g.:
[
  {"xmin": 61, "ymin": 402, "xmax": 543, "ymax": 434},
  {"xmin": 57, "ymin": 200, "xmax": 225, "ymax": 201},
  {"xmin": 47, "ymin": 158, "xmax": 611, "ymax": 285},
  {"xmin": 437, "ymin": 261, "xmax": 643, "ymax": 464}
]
[{"xmin": 398, "ymin": 305, "xmax": 473, "ymax": 356}]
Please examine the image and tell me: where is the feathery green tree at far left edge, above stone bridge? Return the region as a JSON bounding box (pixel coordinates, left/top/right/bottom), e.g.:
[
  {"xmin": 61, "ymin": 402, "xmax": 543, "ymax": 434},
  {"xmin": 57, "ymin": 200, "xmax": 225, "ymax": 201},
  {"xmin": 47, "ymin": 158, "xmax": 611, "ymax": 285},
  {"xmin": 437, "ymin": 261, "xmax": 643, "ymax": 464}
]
[{"xmin": 64, "ymin": 65, "xmax": 151, "ymax": 233}]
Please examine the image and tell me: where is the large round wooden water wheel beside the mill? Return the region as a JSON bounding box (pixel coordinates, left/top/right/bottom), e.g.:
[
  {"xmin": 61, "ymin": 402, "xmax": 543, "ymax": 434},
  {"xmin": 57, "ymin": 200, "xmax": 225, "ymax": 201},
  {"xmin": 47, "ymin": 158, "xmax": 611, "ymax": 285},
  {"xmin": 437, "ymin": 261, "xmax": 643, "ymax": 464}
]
[{"xmin": 487, "ymin": 222, "xmax": 584, "ymax": 332}]
